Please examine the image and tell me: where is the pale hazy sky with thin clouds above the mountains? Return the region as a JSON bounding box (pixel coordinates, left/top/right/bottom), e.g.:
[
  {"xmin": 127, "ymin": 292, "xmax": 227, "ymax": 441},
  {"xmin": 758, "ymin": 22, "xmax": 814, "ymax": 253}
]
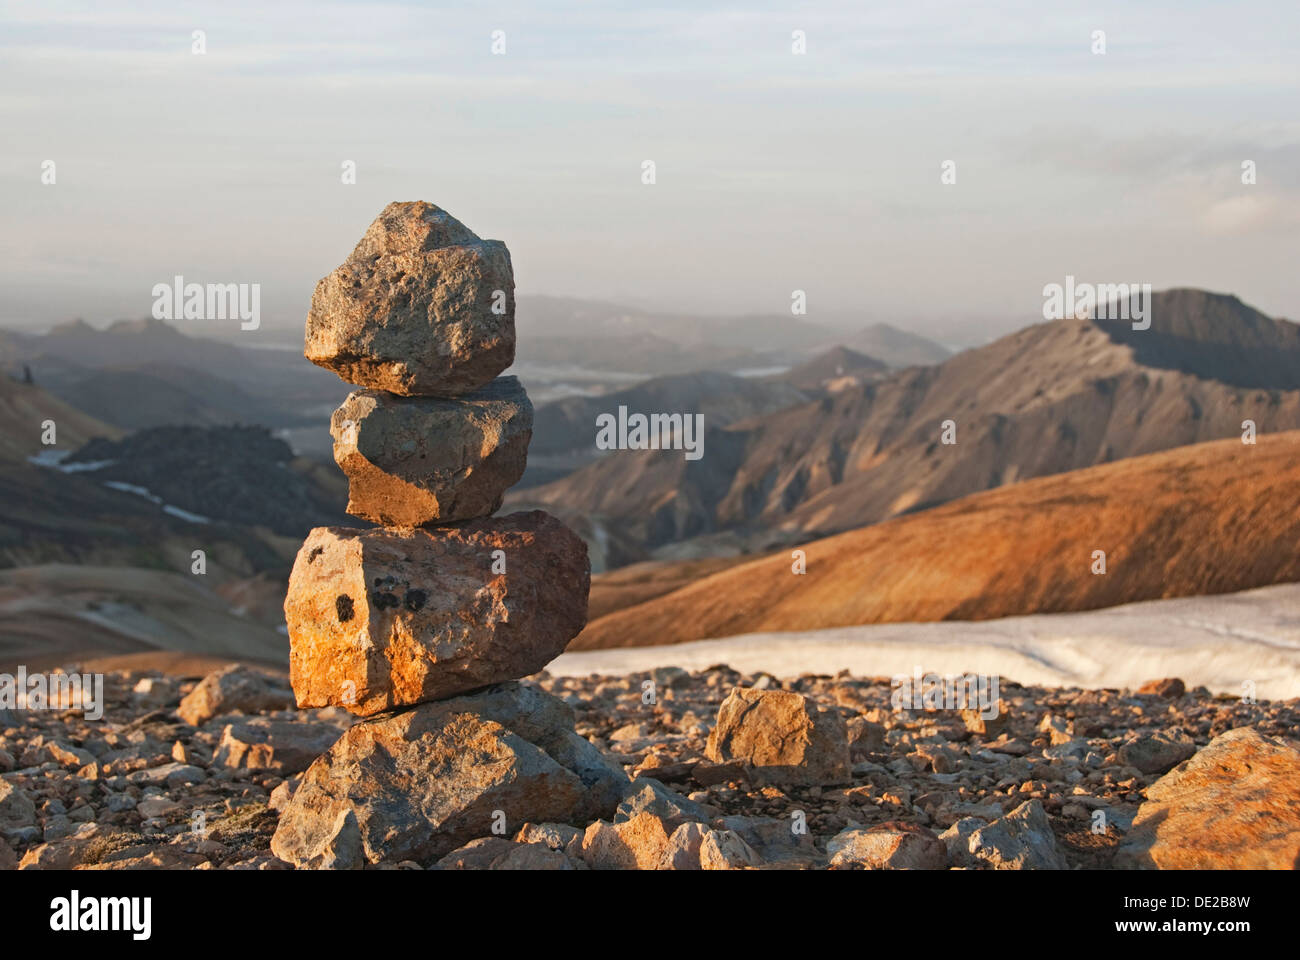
[{"xmin": 0, "ymin": 0, "xmax": 1300, "ymax": 345}]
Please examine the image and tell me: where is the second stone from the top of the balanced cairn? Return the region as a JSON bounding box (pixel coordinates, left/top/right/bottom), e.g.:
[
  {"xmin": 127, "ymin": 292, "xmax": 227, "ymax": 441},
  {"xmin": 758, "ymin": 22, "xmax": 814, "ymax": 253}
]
[{"xmin": 330, "ymin": 377, "xmax": 533, "ymax": 527}]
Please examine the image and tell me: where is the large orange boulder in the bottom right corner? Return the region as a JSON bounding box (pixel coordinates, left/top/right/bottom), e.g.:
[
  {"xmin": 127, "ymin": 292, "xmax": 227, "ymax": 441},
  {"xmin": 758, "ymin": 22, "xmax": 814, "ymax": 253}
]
[{"xmin": 1115, "ymin": 727, "xmax": 1300, "ymax": 870}]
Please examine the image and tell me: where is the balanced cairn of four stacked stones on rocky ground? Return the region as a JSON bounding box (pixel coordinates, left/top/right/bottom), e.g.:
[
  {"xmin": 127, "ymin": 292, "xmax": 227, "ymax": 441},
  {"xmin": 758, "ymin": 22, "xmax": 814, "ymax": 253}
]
[{"xmin": 272, "ymin": 203, "xmax": 628, "ymax": 869}]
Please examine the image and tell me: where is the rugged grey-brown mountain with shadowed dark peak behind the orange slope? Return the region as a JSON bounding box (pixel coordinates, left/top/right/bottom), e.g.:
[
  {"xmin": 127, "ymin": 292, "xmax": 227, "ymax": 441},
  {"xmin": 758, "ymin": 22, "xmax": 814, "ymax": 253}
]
[{"xmin": 507, "ymin": 290, "xmax": 1300, "ymax": 566}]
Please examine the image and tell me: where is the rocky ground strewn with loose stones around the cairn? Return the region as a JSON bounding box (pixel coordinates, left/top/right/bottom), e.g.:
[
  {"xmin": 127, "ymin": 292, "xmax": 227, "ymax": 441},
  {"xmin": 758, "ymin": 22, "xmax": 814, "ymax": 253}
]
[{"xmin": 0, "ymin": 666, "xmax": 1300, "ymax": 869}]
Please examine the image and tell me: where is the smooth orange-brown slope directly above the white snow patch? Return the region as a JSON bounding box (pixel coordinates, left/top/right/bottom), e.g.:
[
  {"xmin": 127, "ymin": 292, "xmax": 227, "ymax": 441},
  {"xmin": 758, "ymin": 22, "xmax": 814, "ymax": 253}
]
[{"xmin": 569, "ymin": 431, "xmax": 1300, "ymax": 650}]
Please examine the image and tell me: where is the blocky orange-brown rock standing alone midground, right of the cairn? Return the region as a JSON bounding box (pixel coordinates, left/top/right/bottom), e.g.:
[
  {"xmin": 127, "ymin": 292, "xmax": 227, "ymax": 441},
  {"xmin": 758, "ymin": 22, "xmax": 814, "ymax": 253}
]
[{"xmin": 705, "ymin": 687, "xmax": 850, "ymax": 784}]
